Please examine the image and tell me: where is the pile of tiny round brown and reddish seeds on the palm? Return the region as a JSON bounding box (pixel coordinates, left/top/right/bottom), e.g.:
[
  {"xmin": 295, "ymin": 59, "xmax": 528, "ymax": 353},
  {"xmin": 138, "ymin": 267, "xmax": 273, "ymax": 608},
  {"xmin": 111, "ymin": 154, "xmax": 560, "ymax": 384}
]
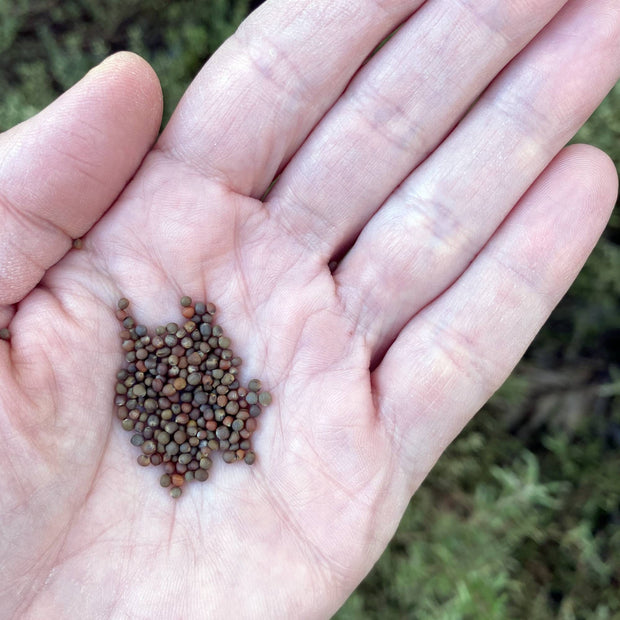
[{"xmin": 115, "ymin": 297, "xmax": 271, "ymax": 498}]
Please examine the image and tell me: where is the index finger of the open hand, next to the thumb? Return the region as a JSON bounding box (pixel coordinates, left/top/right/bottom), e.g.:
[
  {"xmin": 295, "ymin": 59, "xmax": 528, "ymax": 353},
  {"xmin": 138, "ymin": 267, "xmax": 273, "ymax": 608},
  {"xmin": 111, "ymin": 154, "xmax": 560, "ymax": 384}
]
[{"xmin": 157, "ymin": 0, "xmax": 424, "ymax": 197}]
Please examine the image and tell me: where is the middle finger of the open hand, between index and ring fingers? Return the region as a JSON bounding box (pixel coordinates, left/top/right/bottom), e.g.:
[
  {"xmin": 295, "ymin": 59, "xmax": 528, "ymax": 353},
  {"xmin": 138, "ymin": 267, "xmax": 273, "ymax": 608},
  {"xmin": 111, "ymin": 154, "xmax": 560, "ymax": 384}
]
[{"xmin": 267, "ymin": 0, "xmax": 566, "ymax": 260}]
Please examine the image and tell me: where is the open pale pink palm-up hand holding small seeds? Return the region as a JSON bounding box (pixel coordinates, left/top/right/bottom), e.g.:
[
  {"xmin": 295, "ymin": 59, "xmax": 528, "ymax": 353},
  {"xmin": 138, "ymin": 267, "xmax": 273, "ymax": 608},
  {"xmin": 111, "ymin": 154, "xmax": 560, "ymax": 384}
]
[{"xmin": 0, "ymin": 0, "xmax": 620, "ymax": 618}]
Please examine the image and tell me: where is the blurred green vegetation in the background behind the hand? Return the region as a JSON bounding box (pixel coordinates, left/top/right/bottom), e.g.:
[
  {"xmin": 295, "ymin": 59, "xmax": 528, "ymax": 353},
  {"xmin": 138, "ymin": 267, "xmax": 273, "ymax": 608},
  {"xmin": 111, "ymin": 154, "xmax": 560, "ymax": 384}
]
[{"xmin": 0, "ymin": 0, "xmax": 620, "ymax": 620}]
